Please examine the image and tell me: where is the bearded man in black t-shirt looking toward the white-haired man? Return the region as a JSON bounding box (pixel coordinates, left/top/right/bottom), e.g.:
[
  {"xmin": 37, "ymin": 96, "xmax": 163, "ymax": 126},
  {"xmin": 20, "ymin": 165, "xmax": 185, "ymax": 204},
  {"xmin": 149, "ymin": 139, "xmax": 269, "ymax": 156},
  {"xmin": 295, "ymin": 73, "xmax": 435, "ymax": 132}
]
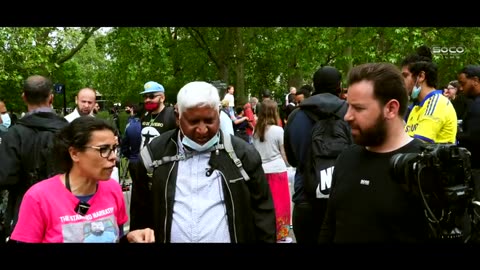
[{"xmin": 319, "ymin": 63, "xmax": 428, "ymax": 243}]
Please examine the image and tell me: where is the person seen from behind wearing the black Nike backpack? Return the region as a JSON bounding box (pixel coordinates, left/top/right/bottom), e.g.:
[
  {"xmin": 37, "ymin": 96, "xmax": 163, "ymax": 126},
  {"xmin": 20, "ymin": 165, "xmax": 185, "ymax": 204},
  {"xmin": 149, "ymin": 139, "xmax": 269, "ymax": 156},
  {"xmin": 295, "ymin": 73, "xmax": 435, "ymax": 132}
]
[{"xmin": 284, "ymin": 66, "xmax": 352, "ymax": 244}]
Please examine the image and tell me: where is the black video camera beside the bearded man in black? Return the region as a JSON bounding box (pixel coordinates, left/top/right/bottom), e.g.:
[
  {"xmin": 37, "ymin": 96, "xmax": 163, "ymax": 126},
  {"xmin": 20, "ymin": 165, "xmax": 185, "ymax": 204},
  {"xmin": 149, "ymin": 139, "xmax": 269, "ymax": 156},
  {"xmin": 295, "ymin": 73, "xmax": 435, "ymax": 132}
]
[{"xmin": 390, "ymin": 144, "xmax": 474, "ymax": 240}]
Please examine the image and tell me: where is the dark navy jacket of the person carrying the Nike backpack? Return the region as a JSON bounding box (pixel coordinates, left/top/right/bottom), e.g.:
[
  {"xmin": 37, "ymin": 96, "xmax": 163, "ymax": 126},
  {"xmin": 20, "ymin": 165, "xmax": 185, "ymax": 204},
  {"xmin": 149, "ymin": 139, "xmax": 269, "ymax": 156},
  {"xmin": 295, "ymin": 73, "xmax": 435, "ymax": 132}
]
[{"xmin": 284, "ymin": 93, "xmax": 348, "ymax": 203}]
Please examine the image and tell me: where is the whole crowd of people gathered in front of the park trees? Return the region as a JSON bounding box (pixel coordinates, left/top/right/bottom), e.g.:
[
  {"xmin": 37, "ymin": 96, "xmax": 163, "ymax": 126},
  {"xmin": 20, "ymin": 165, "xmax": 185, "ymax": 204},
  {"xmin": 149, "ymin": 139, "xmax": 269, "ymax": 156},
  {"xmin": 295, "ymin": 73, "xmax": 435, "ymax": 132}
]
[{"xmin": 0, "ymin": 43, "xmax": 480, "ymax": 244}]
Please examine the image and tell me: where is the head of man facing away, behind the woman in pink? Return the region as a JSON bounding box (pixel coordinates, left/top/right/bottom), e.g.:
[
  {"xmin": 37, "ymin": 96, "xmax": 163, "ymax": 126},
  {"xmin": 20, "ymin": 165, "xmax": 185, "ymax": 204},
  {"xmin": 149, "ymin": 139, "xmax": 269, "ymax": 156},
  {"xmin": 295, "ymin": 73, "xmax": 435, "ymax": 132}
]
[{"xmin": 23, "ymin": 75, "xmax": 53, "ymax": 105}]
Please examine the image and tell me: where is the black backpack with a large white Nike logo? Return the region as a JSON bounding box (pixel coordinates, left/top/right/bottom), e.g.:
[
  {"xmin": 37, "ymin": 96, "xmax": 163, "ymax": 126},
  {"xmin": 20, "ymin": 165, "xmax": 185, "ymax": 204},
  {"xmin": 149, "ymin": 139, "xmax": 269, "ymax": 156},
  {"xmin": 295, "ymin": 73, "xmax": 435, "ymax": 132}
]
[{"xmin": 297, "ymin": 101, "xmax": 353, "ymax": 199}]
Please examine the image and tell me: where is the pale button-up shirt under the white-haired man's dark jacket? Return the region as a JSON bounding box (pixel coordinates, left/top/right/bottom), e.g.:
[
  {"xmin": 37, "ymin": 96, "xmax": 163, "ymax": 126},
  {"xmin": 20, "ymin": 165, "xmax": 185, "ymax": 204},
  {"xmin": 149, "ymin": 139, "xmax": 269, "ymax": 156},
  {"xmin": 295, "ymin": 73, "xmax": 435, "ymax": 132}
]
[{"xmin": 170, "ymin": 142, "xmax": 230, "ymax": 243}]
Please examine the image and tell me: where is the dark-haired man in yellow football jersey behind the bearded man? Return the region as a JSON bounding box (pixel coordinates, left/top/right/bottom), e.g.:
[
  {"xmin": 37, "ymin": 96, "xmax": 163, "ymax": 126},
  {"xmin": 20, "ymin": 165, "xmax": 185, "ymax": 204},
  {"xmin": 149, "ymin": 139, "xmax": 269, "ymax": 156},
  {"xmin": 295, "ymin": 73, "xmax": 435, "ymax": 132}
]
[{"xmin": 401, "ymin": 46, "xmax": 457, "ymax": 143}]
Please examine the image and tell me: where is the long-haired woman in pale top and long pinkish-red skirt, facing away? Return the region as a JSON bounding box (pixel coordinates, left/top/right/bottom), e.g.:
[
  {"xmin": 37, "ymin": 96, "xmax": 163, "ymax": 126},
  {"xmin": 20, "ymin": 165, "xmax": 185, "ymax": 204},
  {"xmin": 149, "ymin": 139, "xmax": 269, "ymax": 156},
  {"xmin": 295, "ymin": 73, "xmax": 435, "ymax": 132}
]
[{"xmin": 253, "ymin": 99, "xmax": 292, "ymax": 243}]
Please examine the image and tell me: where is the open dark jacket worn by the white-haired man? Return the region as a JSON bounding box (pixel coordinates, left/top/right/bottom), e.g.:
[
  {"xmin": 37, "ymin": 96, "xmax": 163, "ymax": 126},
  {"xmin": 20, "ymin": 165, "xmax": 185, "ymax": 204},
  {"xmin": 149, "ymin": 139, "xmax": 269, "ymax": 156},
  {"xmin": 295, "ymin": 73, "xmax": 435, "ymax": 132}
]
[{"xmin": 130, "ymin": 129, "xmax": 276, "ymax": 243}]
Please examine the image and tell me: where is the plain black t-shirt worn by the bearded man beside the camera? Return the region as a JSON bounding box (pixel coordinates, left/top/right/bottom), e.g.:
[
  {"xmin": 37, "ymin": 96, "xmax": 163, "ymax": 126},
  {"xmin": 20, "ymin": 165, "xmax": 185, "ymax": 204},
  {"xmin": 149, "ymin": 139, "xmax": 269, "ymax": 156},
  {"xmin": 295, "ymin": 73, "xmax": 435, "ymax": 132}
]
[{"xmin": 320, "ymin": 139, "xmax": 428, "ymax": 243}]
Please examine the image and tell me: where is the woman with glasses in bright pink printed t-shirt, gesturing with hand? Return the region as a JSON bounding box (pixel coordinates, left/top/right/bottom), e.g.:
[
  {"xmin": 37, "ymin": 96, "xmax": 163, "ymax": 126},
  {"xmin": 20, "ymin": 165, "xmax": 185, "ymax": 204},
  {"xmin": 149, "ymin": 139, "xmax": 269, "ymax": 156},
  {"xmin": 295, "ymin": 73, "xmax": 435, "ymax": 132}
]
[{"xmin": 10, "ymin": 116, "xmax": 154, "ymax": 243}]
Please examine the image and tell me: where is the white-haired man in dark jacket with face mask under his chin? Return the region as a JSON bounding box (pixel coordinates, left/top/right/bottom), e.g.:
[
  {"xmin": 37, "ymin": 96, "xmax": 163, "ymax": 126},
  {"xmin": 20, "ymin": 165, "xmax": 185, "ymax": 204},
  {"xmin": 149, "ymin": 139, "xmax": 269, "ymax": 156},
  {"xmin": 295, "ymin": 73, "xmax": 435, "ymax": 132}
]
[{"xmin": 130, "ymin": 81, "xmax": 276, "ymax": 243}]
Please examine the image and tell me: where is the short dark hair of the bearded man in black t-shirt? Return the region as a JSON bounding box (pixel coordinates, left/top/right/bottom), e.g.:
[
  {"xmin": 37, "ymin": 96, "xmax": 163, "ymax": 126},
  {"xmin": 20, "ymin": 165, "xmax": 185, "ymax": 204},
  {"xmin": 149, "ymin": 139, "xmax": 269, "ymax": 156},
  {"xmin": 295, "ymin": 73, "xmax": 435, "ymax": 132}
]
[{"xmin": 348, "ymin": 63, "xmax": 408, "ymax": 117}]
